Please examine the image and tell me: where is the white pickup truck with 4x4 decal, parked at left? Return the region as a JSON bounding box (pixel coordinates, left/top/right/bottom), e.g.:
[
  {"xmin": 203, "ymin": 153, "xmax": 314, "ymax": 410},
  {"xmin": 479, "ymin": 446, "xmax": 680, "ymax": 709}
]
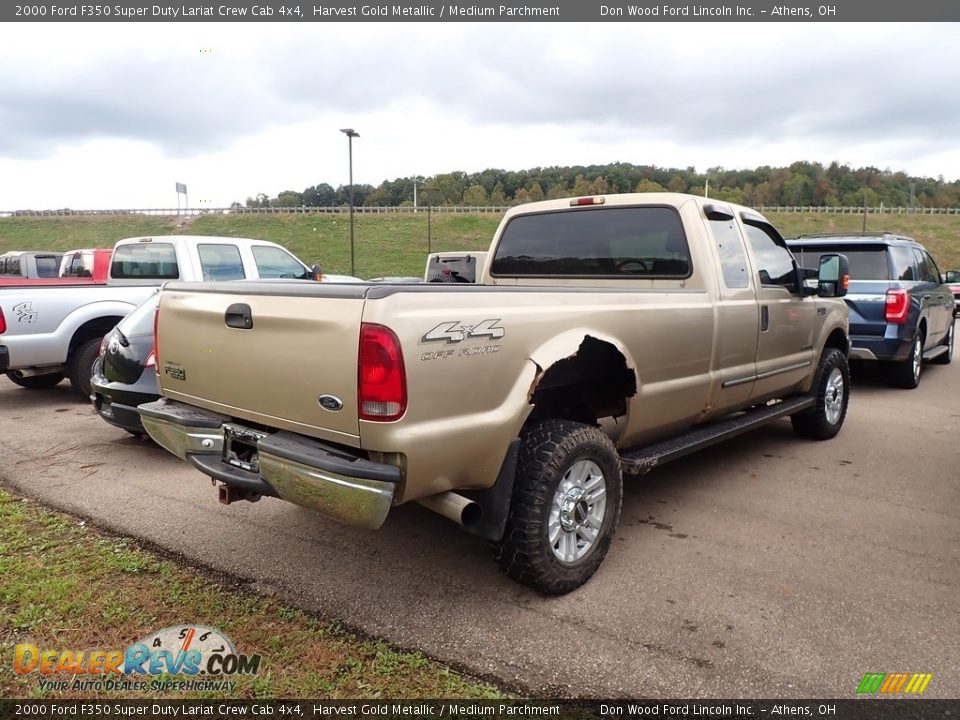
[{"xmin": 0, "ymin": 235, "xmax": 319, "ymax": 398}]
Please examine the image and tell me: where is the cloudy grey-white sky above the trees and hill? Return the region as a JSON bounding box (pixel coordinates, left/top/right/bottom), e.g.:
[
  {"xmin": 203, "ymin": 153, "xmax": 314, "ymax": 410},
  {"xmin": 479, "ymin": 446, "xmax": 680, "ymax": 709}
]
[{"xmin": 0, "ymin": 22, "xmax": 960, "ymax": 211}]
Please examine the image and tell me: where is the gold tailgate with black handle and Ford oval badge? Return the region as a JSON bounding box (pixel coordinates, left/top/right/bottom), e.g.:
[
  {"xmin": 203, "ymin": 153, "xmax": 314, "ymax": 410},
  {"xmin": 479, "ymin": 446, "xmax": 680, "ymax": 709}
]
[{"xmin": 157, "ymin": 282, "xmax": 367, "ymax": 442}]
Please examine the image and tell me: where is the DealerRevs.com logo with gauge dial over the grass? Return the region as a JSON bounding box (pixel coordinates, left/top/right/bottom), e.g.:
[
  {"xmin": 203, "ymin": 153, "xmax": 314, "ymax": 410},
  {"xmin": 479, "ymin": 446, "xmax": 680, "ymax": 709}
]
[{"xmin": 13, "ymin": 625, "xmax": 263, "ymax": 692}]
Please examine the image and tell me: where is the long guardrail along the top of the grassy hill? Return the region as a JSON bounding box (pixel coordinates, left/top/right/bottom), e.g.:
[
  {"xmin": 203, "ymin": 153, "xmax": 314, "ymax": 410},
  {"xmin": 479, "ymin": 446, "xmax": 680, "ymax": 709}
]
[{"xmin": 0, "ymin": 205, "xmax": 960, "ymax": 218}]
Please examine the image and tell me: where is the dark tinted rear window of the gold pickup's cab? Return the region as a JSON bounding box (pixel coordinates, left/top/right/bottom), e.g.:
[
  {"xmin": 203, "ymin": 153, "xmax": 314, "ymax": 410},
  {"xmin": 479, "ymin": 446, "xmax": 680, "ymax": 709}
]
[{"xmin": 490, "ymin": 206, "xmax": 693, "ymax": 278}]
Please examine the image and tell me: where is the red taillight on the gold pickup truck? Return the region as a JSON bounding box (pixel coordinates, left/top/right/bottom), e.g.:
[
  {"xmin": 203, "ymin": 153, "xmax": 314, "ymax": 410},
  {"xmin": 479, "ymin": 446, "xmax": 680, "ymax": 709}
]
[{"xmin": 357, "ymin": 323, "xmax": 407, "ymax": 422}]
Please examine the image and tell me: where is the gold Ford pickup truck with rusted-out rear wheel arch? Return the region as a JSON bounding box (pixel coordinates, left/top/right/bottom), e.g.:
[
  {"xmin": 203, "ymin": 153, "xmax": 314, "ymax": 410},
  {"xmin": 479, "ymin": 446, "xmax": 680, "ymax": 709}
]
[{"xmin": 139, "ymin": 193, "xmax": 850, "ymax": 594}]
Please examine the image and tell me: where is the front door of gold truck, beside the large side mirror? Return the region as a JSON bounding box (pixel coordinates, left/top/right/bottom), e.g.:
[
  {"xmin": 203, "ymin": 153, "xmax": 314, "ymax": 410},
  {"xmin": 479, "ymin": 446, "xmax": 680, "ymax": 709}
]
[{"xmin": 741, "ymin": 216, "xmax": 817, "ymax": 400}]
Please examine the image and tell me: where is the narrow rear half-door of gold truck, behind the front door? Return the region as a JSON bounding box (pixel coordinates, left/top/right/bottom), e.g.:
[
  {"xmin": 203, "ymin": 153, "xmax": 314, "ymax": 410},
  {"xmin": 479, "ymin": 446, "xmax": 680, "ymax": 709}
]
[{"xmin": 708, "ymin": 212, "xmax": 760, "ymax": 411}]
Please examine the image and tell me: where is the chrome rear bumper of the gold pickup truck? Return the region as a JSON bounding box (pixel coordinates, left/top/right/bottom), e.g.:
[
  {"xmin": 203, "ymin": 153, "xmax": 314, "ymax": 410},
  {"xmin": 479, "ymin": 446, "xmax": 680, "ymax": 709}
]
[{"xmin": 138, "ymin": 398, "xmax": 400, "ymax": 529}]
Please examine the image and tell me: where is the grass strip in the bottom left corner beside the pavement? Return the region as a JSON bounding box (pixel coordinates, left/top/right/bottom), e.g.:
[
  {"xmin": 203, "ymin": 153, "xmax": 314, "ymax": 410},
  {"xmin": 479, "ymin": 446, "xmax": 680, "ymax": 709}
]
[{"xmin": 0, "ymin": 490, "xmax": 503, "ymax": 699}]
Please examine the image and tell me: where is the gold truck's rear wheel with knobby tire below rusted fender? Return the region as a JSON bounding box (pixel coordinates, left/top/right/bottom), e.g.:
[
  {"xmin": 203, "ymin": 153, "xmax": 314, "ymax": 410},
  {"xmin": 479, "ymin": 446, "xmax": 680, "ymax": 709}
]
[{"xmin": 494, "ymin": 420, "xmax": 623, "ymax": 595}]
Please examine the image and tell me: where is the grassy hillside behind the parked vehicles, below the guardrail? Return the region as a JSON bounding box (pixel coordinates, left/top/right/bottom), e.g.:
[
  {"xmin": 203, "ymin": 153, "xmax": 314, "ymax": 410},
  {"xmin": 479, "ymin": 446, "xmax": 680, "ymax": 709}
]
[{"xmin": 0, "ymin": 212, "xmax": 960, "ymax": 277}]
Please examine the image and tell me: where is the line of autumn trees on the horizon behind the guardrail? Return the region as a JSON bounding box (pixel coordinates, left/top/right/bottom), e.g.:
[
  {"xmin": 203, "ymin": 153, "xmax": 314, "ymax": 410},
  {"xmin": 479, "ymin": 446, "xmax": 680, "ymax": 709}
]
[{"xmin": 233, "ymin": 162, "xmax": 960, "ymax": 207}]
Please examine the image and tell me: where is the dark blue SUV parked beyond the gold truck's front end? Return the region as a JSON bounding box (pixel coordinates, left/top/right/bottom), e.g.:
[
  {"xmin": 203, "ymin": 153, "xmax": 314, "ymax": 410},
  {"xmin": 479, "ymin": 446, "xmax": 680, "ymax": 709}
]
[{"xmin": 787, "ymin": 233, "xmax": 954, "ymax": 388}]
